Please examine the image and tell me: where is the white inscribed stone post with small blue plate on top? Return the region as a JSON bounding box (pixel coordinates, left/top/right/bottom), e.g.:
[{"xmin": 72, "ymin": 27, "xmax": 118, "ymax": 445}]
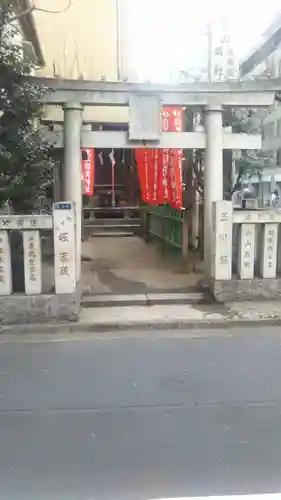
[{"xmin": 53, "ymin": 202, "xmax": 76, "ymax": 294}]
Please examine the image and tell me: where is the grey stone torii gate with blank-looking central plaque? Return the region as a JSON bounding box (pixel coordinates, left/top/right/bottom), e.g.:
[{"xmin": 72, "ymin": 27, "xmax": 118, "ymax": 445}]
[{"xmin": 32, "ymin": 77, "xmax": 281, "ymax": 278}]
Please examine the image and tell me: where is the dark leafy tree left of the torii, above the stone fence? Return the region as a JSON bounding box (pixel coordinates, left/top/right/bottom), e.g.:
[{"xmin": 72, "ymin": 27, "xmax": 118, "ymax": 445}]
[{"xmin": 0, "ymin": 0, "xmax": 54, "ymax": 212}]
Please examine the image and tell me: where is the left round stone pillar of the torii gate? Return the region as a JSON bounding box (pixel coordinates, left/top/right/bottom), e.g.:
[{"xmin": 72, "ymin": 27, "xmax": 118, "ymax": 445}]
[{"xmin": 62, "ymin": 102, "xmax": 83, "ymax": 281}]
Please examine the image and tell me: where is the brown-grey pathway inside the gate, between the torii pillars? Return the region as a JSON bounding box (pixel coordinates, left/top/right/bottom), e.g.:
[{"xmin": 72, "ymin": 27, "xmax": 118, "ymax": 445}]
[{"xmin": 82, "ymin": 237, "xmax": 203, "ymax": 294}]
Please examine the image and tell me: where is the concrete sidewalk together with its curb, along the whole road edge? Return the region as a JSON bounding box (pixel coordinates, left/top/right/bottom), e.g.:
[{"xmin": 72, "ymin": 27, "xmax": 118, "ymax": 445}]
[{"xmin": 0, "ymin": 302, "xmax": 281, "ymax": 335}]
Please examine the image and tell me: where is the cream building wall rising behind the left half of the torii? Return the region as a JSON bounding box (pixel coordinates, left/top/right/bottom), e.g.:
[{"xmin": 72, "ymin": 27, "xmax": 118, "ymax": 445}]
[{"xmin": 34, "ymin": 0, "xmax": 128, "ymax": 122}]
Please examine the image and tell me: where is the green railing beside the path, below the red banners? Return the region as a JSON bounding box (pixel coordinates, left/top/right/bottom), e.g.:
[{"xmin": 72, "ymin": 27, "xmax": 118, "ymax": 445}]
[{"xmin": 144, "ymin": 205, "xmax": 188, "ymax": 255}]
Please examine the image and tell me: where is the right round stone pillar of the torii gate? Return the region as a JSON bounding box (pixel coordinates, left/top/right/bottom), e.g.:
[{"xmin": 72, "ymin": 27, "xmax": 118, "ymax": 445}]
[{"xmin": 204, "ymin": 106, "xmax": 223, "ymax": 269}]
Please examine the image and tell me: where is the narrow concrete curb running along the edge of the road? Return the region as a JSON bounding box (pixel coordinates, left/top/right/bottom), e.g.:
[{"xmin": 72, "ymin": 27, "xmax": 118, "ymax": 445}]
[{"xmin": 0, "ymin": 317, "xmax": 281, "ymax": 336}]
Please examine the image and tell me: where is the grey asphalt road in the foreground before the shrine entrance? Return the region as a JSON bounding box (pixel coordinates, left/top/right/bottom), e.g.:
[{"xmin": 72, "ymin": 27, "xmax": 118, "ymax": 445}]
[{"xmin": 0, "ymin": 328, "xmax": 281, "ymax": 500}]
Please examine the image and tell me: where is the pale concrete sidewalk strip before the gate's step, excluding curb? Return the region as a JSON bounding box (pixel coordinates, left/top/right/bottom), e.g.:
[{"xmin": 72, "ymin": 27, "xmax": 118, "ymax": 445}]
[{"xmin": 80, "ymin": 302, "xmax": 281, "ymax": 330}]
